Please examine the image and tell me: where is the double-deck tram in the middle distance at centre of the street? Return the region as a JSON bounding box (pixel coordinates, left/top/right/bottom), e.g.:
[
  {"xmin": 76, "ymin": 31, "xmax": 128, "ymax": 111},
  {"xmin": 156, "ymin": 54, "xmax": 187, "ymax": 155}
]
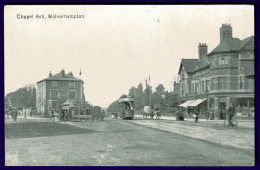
[{"xmin": 119, "ymin": 95, "xmax": 134, "ymax": 120}]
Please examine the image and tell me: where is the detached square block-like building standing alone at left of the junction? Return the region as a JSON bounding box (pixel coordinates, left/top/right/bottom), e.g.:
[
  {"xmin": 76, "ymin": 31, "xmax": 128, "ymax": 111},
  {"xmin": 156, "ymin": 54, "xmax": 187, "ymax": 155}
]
[{"xmin": 36, "ymin": 70, "xmax": 84, "ymax": 117}]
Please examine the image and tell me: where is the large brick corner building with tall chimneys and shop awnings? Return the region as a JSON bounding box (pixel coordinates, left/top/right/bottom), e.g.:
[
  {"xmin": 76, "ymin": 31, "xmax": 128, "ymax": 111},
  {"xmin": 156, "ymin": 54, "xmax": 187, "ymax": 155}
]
[{"xmin": 176, "ymin": 24, "xmax": 255, "ymax": 119}]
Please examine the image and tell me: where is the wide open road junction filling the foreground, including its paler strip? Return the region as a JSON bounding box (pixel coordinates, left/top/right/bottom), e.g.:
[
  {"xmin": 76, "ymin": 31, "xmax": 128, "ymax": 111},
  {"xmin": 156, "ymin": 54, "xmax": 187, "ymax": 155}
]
[{"xmin": 5, "ymin": 117, "xmax": 255, "ymax": 166}]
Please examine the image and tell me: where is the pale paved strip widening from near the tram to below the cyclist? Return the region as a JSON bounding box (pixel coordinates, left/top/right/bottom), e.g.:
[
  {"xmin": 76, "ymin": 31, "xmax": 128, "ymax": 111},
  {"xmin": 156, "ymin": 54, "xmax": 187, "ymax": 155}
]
[{"xmin": 133, "ymin": 120, "xmax": 255, "ymax": 150}]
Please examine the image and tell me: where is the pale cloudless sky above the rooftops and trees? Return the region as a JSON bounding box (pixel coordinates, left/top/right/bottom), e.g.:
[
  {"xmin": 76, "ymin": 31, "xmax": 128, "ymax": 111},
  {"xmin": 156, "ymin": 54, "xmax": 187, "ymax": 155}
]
[{"xmin": 4, "ymin": 5, "xmax": 255, "ymax": 107}]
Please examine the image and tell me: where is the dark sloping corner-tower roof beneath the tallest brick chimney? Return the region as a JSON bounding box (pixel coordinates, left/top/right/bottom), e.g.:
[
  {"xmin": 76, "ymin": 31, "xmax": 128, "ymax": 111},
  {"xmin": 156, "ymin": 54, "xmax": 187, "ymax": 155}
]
[{"xmin": 208, "ymin": 38, "xmax": 241, "ymax": 56}]
